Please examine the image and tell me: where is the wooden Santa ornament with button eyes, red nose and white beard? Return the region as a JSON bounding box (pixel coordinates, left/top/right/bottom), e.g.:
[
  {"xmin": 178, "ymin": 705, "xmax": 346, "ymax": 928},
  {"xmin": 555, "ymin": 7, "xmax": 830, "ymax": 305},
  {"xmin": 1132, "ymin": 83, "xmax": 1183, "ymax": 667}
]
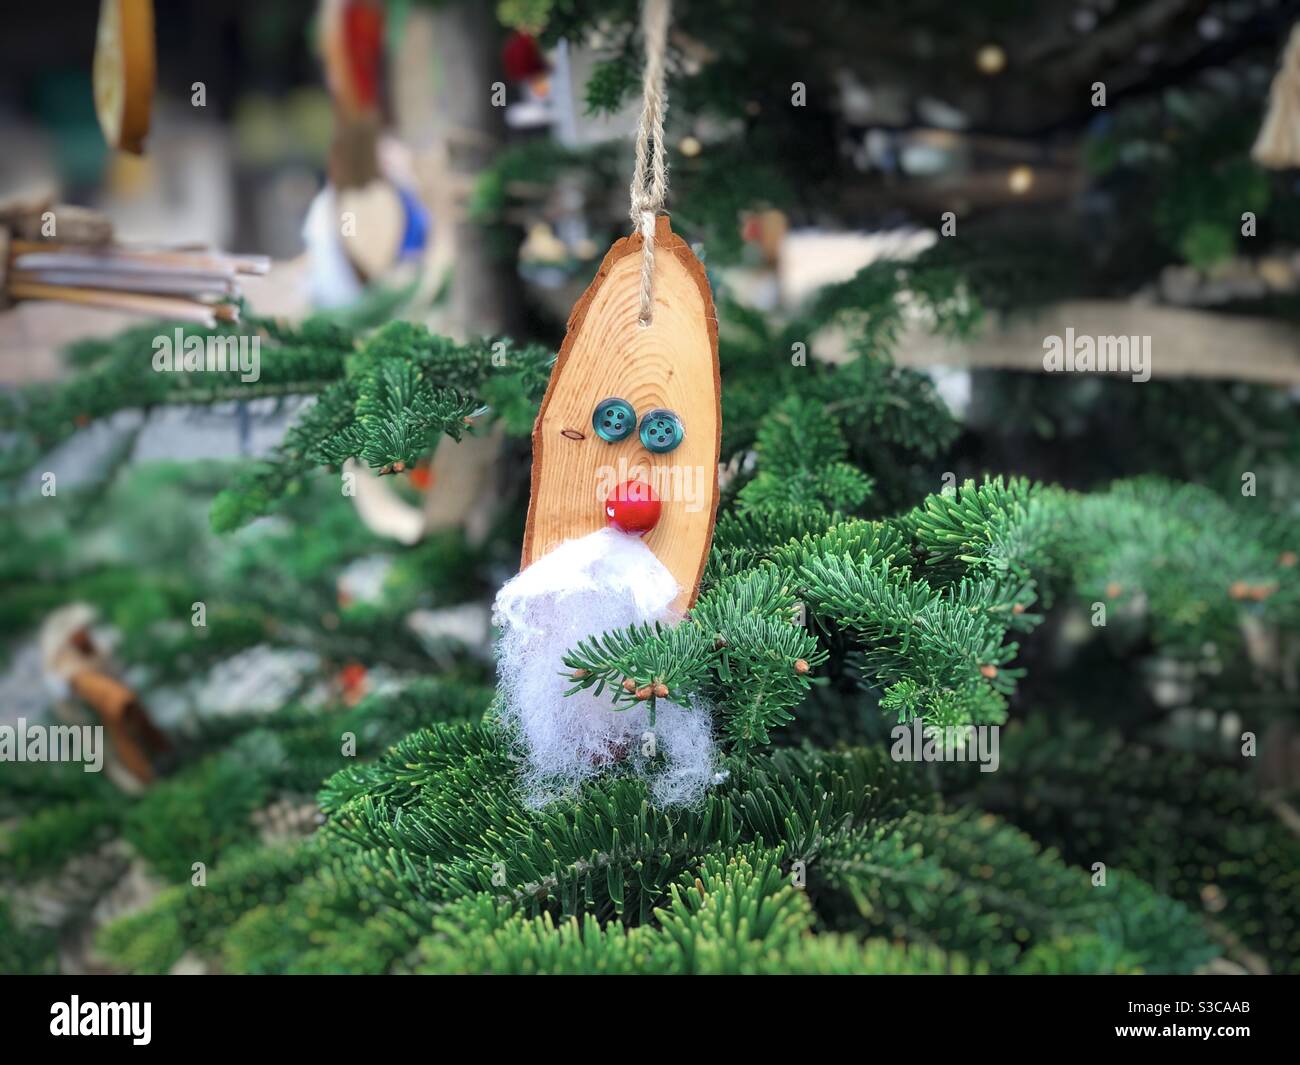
[{"xmin": 497, "ymin": 217, "xmax": 722, "ymax": 806}]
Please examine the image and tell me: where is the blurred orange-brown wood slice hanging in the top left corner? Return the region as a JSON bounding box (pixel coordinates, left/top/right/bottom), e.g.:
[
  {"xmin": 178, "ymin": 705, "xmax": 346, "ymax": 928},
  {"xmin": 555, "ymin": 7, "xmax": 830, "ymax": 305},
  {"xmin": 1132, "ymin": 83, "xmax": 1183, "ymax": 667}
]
[{"xmin": 94, "ymin": 0, "xmax": 156, "ymax": 155}]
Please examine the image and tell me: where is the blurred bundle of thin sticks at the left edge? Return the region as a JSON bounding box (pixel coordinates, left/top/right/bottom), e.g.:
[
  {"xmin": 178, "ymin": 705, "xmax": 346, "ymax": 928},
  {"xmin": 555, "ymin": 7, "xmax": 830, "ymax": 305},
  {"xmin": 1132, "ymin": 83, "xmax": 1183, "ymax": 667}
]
[{"xmin": 0, "ymin": 196, "xmax": 270, "ymax": 328}]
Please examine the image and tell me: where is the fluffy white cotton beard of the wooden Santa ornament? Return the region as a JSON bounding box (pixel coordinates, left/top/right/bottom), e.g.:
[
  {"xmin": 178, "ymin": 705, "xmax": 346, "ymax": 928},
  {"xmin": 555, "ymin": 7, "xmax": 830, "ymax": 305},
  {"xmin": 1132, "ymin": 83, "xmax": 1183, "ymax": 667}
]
[{"xmin": 495, "ymin": 529, "xmax": 715, "ymax": 808}]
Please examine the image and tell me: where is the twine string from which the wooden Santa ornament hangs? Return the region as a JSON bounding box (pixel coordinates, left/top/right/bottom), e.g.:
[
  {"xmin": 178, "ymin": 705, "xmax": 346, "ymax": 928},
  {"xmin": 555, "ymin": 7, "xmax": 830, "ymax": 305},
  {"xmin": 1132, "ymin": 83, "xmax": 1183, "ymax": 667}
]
[{"xmin": 631, "ymin": 0, "xmax": 672, "ymax": 325}]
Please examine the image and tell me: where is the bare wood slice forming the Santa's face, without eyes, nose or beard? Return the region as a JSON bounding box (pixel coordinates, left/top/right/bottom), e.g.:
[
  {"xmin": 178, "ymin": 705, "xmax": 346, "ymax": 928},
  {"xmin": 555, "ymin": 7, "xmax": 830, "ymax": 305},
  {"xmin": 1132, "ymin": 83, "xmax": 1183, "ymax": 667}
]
[{"xmin": 523, "ymin": 216, "xmax": 722, "ymax": 611}]
